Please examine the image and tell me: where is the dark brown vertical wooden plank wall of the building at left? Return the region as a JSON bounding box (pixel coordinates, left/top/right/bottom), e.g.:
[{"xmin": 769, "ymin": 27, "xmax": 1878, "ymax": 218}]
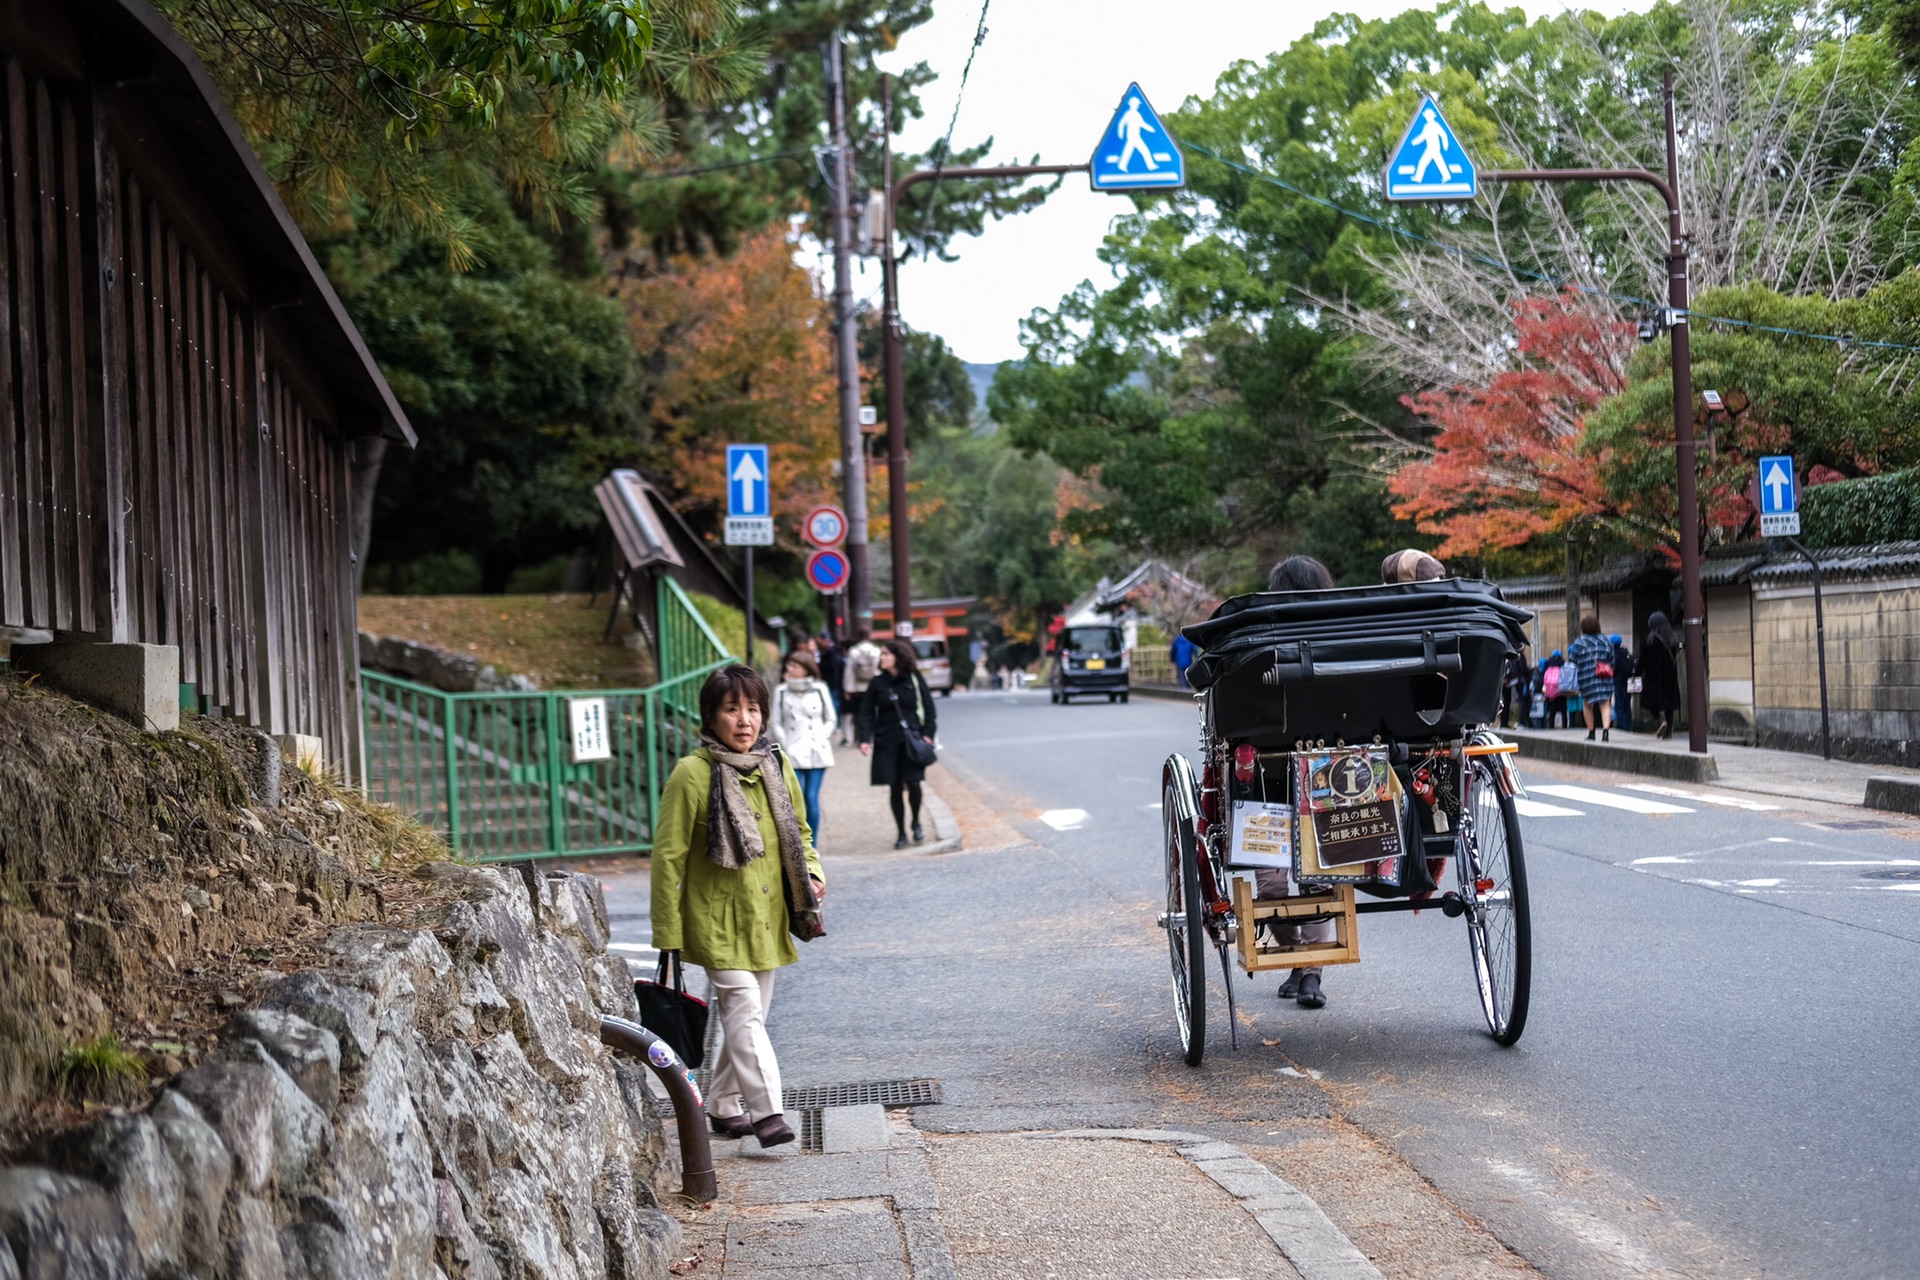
[{"xmin": 0, "ymin": 59, "xmax": 357, "ymax": 771}]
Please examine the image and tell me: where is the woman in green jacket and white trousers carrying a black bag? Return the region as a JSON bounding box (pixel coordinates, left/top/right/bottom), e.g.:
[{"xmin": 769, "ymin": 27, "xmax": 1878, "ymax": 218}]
[{"xmin": 653, "ymin": 666, "xmax": 826, "ymax": 1148}]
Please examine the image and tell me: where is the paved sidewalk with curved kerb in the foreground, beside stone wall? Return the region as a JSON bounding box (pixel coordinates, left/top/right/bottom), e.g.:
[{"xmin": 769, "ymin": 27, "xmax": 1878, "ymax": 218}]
[{"xmin": 674, "ymin": 1103, "xmax": 1390, "ymax": 1280}]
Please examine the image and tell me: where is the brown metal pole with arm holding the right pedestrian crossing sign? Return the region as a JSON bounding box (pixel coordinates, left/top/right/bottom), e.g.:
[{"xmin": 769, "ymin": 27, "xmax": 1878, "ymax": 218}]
[{"xmin": 1480, "ymin": 71, "xmax": 1707, "ymax": 750}]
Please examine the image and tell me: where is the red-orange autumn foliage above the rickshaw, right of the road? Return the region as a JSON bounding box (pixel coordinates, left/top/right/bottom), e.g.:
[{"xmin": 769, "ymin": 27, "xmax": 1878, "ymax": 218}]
[{"xmin": 1390, "ymin": 290, "xmax": 1634, "ymax": 558}]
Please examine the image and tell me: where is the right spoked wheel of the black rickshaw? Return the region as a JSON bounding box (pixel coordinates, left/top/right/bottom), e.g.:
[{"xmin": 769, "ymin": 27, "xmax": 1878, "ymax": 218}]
[{"xmin": 1461, "ymin": 760, "xmax": 1534, "ymax": 1044}]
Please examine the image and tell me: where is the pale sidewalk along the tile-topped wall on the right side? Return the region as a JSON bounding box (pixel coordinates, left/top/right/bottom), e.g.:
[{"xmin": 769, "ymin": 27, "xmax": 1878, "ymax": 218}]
[{"xmin": 1500, "ymin": 729, "xmax": 1920, "ymax": 814}]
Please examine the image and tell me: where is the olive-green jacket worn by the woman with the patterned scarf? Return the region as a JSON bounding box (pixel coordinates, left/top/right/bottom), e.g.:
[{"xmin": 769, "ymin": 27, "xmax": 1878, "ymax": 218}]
[{"xmin": 653, "ymin": 747, "xmax": 826, "ymax": 973}]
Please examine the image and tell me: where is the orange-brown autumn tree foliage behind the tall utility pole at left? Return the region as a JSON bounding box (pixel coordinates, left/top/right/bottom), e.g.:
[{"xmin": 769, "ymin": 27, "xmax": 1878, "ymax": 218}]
[{"xmin": 618, "ymin": 226, "xmax": 839, "ymax": 547}]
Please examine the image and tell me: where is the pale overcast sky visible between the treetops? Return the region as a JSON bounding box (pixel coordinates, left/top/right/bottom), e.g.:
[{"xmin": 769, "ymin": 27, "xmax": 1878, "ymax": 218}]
[{"xmin": 840, "ymin": 0, "xmax": 1645, "ymax": 363}]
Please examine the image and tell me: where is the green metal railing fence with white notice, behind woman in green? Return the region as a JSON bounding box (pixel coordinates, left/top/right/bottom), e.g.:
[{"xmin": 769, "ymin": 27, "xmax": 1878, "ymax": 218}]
[{"xmin": 361, "ymin": 580, "xmax": 735, "ymax": 862}]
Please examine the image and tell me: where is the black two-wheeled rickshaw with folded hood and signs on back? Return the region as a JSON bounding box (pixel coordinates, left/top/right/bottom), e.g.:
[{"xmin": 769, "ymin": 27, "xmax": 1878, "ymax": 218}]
[{"xmin": 1160, "ymin": 578, "xmax": 1532, "ymax": 1067}]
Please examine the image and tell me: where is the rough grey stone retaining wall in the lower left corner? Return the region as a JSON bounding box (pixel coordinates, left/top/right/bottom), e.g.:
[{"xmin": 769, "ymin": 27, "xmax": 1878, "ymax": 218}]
[{"xmin": 0, "ymin": 864, "xmax": 680, "ymax": 1280}]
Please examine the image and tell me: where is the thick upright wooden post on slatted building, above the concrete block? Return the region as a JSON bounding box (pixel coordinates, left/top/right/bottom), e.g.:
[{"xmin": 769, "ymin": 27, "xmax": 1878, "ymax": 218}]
[{"xmin": 81, "ymin": 126, "xmax": 129, "ymax": 645}]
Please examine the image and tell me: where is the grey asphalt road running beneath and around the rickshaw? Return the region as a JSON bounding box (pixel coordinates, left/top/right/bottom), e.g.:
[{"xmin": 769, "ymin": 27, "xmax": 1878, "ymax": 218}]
[{"xmin": 913, "ymin": 693, "xmax": 1920, "ymax": 1276}]
